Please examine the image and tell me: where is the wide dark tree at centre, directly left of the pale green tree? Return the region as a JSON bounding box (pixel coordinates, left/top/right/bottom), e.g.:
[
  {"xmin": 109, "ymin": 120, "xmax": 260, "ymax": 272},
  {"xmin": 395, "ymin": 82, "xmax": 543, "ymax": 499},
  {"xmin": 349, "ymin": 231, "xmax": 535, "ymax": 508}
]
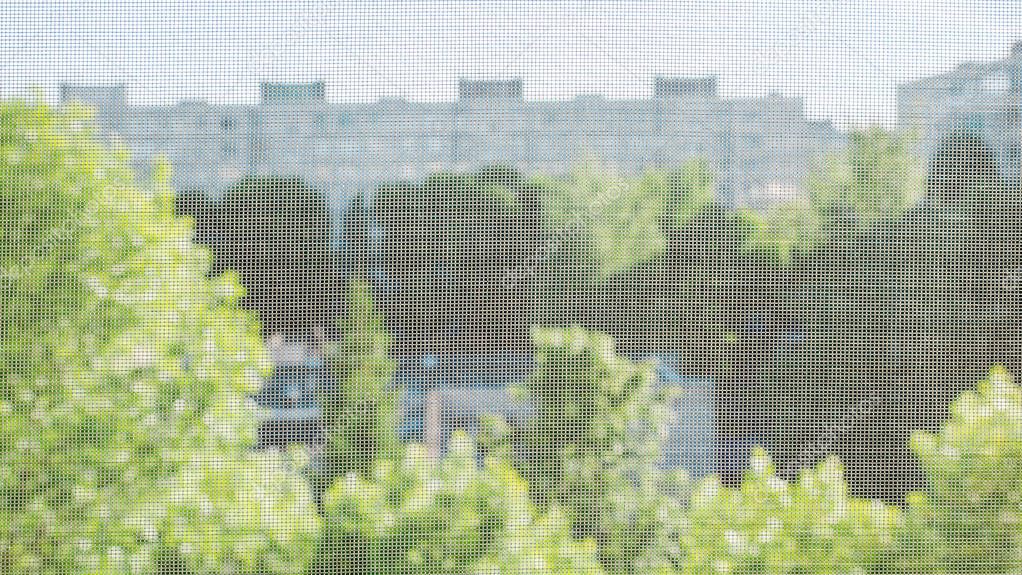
[{"xmin": 372, "ymin": 166, "xmax": 544, "ymax": 348}]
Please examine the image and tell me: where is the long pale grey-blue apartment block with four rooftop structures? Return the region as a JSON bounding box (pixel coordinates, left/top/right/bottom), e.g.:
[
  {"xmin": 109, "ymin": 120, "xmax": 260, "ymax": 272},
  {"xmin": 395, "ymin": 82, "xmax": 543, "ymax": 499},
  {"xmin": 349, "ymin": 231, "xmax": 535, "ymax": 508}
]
[{"xmin": 60, "ymin": 77, "xmax": 844, "ymax": 220}]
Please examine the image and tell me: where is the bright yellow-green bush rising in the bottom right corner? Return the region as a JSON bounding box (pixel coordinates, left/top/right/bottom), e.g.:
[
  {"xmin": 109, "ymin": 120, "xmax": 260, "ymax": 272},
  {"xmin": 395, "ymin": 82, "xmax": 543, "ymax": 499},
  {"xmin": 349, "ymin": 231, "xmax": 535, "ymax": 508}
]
[{"xmin": 897, "ymin": 368, "xmax": 1022, "ymax": 573}]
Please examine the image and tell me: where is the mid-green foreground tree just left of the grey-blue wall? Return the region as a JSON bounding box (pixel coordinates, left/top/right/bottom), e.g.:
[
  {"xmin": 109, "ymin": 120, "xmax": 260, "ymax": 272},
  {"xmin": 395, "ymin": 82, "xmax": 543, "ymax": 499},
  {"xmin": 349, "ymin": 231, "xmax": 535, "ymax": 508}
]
[{"xmin": 496, "ymin": 328, "xmax": 688, "ymax": 573}]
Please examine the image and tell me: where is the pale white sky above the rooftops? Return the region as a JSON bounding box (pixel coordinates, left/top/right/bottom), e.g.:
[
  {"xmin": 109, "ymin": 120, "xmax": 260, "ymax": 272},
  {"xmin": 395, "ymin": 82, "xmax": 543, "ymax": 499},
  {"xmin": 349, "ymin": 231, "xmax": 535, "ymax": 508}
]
[{"xmin": 0, "ymin": 0, "xmax": 1022, "ymax": 127}]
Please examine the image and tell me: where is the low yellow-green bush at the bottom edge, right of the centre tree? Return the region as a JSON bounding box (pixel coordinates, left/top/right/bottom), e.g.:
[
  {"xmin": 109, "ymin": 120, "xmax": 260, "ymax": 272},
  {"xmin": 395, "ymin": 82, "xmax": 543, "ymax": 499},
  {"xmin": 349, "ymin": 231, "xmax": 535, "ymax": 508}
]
[{"xmin": 681, "ymin": 449, "xmax": 899, "ymax": 574}]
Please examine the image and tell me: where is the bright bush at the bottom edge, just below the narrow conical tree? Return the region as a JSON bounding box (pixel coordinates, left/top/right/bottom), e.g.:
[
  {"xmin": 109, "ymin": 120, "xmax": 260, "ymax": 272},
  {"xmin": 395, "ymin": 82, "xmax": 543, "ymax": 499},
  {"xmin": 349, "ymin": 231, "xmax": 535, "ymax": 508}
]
[{"xmin": 314, "ymin": 433, "xmax": 601, "ymax": 575}]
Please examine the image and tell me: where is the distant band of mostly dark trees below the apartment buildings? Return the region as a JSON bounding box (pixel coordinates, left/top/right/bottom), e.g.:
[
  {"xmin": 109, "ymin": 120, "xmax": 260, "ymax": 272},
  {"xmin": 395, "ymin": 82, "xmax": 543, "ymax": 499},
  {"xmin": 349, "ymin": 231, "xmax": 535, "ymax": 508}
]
[{"xmin": 178, "ymin": 130, "xmax": 1022, "ymax": 497}]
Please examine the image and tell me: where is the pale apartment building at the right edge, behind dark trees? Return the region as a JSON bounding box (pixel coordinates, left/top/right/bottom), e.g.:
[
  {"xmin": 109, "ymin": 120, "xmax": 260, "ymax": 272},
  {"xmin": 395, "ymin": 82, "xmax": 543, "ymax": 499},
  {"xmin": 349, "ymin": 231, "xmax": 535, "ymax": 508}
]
[{"xmin": 897, "ymin": 41, "xmax": 1022, "ymax": 187}]
